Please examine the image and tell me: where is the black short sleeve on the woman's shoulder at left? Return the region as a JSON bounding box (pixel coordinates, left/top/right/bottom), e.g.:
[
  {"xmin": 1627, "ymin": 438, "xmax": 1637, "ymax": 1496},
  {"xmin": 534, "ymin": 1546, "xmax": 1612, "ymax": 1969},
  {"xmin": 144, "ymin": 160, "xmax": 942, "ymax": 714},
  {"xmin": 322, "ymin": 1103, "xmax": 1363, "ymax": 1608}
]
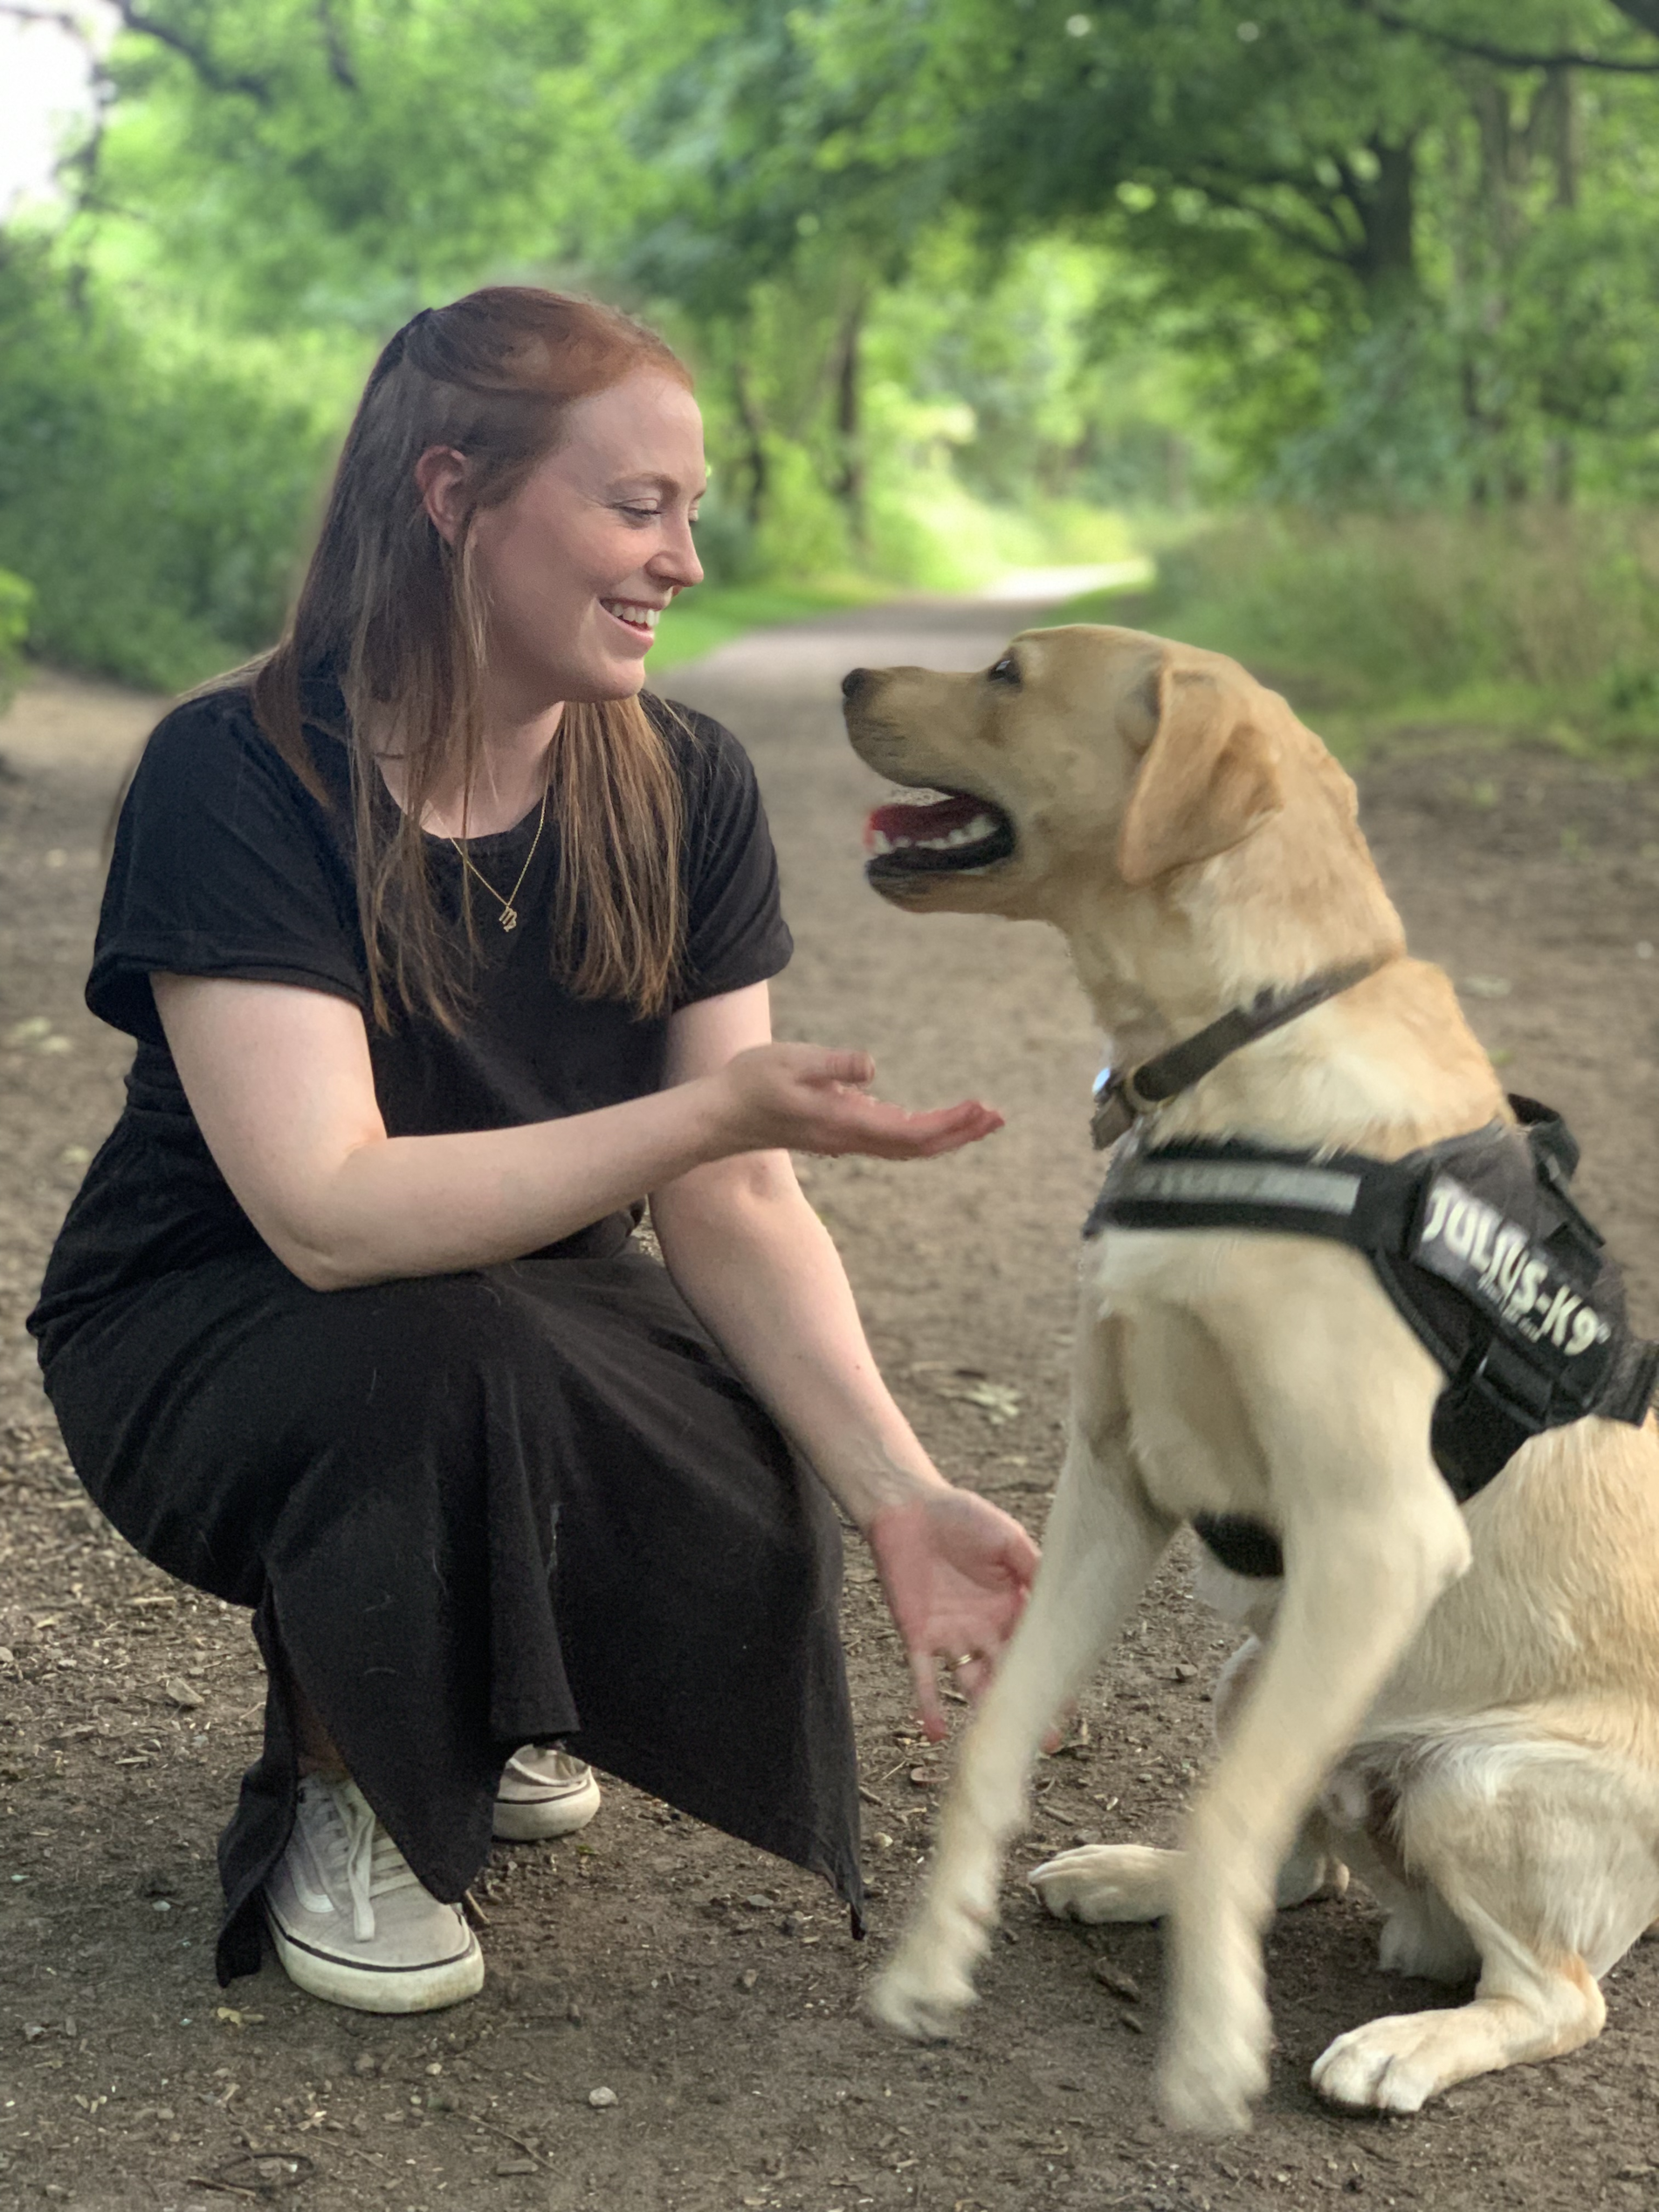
[{"xmin": 86, "ymin": 693, "xmax": 368, "ymax": 1044}]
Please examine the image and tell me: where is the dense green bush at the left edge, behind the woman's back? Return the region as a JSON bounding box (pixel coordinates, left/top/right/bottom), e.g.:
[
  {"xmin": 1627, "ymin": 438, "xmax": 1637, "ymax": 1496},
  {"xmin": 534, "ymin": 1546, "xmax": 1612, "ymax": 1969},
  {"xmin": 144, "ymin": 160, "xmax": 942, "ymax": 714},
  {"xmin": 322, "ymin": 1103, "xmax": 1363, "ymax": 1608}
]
[{"xmin": 0, "ymin": 244, "xmax": 338, "ymax": 690}]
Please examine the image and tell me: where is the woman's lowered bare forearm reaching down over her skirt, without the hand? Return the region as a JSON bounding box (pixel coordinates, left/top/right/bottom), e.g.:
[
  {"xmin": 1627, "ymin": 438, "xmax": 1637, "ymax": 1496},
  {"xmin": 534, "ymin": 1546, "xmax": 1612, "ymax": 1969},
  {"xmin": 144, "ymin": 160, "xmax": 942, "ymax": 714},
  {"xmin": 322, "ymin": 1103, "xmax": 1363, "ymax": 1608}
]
[{"xmin": 651, "ymin": 1153, "xmax": 945, "ymax": 1528}]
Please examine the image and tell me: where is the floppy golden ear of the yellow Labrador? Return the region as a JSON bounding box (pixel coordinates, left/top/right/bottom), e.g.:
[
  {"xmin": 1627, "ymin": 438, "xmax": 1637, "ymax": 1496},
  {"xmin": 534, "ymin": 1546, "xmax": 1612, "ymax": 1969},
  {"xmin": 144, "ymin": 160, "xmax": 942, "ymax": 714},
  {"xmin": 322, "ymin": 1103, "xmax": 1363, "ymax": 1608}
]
[{"xmin": 1117, "ymin": 664, "xmax": 1285, "ymax": 885}]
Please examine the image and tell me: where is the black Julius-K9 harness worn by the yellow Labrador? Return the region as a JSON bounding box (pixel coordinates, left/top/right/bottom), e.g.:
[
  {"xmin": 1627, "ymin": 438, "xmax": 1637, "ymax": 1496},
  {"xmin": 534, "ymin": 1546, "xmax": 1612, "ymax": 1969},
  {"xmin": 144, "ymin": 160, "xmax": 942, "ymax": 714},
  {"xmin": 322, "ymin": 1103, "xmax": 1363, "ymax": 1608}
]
[{"xmin": 1084, "ymin": 974, "xmax": 1659, "ymax": 1575}]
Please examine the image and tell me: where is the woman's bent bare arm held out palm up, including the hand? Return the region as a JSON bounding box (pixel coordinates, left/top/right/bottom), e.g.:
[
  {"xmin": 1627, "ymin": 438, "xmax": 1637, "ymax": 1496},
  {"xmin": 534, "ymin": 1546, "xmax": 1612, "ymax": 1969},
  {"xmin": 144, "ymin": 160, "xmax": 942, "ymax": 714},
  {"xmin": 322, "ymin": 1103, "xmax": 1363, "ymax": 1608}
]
[{"xmin": 153, "ymin": 975, "xmax": 998, "ymax": 1290}]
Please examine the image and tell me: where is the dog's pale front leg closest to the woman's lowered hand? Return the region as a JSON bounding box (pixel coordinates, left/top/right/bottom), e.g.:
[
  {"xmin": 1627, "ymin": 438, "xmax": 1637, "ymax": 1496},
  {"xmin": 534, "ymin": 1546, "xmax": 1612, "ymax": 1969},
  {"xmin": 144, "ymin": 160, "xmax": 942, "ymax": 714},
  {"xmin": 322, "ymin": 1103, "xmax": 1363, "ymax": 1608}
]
[{"xmin": 870, "ymin": 1345, "xmax": 1174, "ymax": 2042}]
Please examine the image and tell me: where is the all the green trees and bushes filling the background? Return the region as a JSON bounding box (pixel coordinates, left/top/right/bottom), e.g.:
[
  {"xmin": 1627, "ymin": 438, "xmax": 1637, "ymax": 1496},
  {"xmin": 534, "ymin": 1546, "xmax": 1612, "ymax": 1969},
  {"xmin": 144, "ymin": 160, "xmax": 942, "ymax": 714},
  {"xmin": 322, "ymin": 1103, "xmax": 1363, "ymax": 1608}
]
[{"xmin": 0, "ymin": 0, "xmax": 1659, "ymax": 721}]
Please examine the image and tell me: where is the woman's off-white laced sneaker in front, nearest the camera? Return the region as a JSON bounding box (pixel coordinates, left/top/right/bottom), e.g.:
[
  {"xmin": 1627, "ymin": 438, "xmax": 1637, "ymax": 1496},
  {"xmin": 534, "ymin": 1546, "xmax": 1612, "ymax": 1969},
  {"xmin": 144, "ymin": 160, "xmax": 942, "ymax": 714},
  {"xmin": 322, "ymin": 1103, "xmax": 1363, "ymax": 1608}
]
[{"xmin": 265, "ymin": 1774, "xmax": 485, "ymax": 2013}]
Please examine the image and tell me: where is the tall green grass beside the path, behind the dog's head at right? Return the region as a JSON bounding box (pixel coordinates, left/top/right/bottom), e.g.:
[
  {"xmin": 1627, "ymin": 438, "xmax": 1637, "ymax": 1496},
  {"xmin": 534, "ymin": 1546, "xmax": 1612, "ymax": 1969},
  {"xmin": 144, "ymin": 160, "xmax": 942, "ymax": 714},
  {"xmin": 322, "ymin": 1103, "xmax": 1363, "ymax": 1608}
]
[{"xmin": 1146, "ymin": 509, "xmax": 1659, "ymax": 739}]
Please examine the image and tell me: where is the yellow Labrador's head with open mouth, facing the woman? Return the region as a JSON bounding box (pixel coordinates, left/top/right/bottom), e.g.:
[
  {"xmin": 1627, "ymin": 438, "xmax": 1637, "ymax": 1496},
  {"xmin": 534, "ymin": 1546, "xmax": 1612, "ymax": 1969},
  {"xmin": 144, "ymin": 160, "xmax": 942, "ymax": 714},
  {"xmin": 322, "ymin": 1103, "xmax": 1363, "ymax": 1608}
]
[{"xmin": 843, "ymin": 624, "xmax": 1353, "ymax": 916}]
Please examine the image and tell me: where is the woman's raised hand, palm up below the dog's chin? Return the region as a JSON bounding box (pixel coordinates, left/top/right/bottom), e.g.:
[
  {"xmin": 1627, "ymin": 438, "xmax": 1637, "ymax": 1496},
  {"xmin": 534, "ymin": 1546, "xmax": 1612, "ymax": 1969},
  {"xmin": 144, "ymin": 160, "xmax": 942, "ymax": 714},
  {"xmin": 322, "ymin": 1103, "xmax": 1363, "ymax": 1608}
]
[{"xmin": 710, "ymin": 1044, "xmax": 1002, "ymax": 1159}]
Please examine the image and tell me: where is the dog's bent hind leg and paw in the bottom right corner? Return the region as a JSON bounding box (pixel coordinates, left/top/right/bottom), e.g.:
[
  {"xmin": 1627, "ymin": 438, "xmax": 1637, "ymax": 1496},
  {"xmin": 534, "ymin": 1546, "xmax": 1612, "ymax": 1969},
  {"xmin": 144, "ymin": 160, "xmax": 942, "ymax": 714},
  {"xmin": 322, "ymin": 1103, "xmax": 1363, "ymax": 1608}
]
[{"xmin": 1314, "ymin": 1714, "xmax": 1659, "ymax": 2112}]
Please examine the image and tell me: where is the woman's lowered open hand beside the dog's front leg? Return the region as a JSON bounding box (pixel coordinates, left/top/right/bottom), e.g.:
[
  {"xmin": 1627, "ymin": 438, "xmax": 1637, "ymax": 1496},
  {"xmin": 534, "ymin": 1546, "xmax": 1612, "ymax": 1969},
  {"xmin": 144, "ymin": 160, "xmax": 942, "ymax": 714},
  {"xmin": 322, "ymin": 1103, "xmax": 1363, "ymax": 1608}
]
[{"xmin": 865, "ymin": 1485, "xmax": 1037, "ymax": 1743}]
